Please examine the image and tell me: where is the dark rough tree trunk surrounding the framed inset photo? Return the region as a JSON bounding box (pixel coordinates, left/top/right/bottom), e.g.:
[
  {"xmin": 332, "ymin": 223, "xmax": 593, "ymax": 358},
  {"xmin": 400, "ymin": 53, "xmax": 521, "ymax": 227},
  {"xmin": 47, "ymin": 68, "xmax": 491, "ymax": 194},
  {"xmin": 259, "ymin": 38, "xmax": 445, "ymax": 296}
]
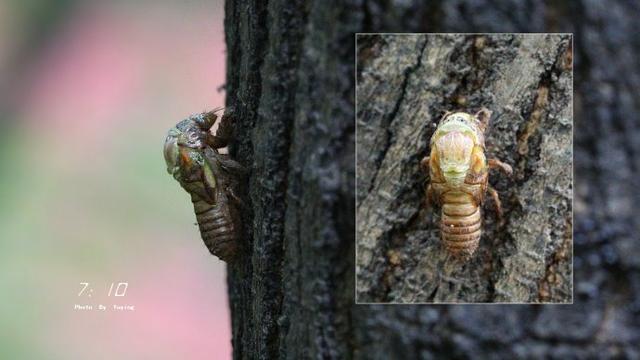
[{"xmin": 225, "ymin": 0, "xmax": 640, "ymax": 359}]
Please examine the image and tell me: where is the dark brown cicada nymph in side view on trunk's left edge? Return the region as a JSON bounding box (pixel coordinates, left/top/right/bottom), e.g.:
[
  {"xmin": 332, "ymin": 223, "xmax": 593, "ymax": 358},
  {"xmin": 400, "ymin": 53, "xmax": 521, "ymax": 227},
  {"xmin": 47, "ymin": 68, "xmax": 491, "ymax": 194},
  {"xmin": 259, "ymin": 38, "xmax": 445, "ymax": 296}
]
[{"xmin": 164, "ymin": 109, "xmax": 245, "ymax": 262}]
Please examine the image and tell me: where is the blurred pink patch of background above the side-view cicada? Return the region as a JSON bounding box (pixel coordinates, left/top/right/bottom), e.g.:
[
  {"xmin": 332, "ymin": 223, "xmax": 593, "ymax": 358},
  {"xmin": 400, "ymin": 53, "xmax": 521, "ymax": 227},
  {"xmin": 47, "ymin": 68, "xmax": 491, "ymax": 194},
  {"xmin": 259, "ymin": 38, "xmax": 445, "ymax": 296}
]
[{"xmin": 18, "ymin": 2, "xmax": 225, "ymax": 146}]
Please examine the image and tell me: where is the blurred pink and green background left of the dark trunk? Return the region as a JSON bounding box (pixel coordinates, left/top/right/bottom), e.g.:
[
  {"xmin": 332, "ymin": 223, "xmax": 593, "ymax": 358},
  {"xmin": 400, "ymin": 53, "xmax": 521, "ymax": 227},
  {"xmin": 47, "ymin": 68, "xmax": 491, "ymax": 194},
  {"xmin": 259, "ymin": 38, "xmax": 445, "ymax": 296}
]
[{"xmin": 0, "ymin": 0, "xmax": 231, "ymax": 359}]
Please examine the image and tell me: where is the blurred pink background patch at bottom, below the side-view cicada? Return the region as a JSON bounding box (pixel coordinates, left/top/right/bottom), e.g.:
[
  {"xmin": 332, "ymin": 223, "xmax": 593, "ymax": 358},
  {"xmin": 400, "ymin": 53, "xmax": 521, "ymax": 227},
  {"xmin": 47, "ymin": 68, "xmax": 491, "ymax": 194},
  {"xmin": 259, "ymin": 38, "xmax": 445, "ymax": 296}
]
[{"xmin": 54, "ymin": 248, "xmax": 231, "ymax": 360}]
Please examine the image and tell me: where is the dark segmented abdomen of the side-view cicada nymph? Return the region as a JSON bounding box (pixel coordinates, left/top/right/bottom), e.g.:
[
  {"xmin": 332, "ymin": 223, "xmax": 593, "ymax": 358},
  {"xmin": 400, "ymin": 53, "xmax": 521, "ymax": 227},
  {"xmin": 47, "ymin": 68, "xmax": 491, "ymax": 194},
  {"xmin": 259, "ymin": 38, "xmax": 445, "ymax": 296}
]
[{"xmin": 193, "ymin": 200, "xmax": 236, "ymax": 261}]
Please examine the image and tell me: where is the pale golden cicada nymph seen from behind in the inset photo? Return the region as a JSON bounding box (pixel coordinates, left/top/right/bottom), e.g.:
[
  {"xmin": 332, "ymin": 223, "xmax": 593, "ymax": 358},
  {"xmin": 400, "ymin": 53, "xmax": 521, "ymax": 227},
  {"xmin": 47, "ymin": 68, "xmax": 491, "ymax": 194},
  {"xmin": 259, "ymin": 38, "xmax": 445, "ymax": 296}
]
[{"xmin": 421, "ymin": 108, "xmax": 512, "ymax": 259}]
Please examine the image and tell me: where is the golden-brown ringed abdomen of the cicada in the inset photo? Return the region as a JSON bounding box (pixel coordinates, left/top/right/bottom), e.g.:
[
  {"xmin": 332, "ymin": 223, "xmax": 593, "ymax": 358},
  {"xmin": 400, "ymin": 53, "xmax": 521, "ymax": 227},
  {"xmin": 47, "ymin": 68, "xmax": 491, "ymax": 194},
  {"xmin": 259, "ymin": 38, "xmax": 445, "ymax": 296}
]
[{"xmin": 440, "ymin": 192, "xmax": 482, "ymax": 258}]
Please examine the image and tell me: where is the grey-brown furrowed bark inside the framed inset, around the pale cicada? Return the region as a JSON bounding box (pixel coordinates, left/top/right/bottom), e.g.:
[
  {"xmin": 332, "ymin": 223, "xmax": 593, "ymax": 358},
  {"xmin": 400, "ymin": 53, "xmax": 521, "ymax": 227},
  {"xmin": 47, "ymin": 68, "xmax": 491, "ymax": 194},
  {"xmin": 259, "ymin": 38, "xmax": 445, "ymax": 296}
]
[{"xmin": 356, "ymin": 34, "xmax": 573, "ymax": 303}]
